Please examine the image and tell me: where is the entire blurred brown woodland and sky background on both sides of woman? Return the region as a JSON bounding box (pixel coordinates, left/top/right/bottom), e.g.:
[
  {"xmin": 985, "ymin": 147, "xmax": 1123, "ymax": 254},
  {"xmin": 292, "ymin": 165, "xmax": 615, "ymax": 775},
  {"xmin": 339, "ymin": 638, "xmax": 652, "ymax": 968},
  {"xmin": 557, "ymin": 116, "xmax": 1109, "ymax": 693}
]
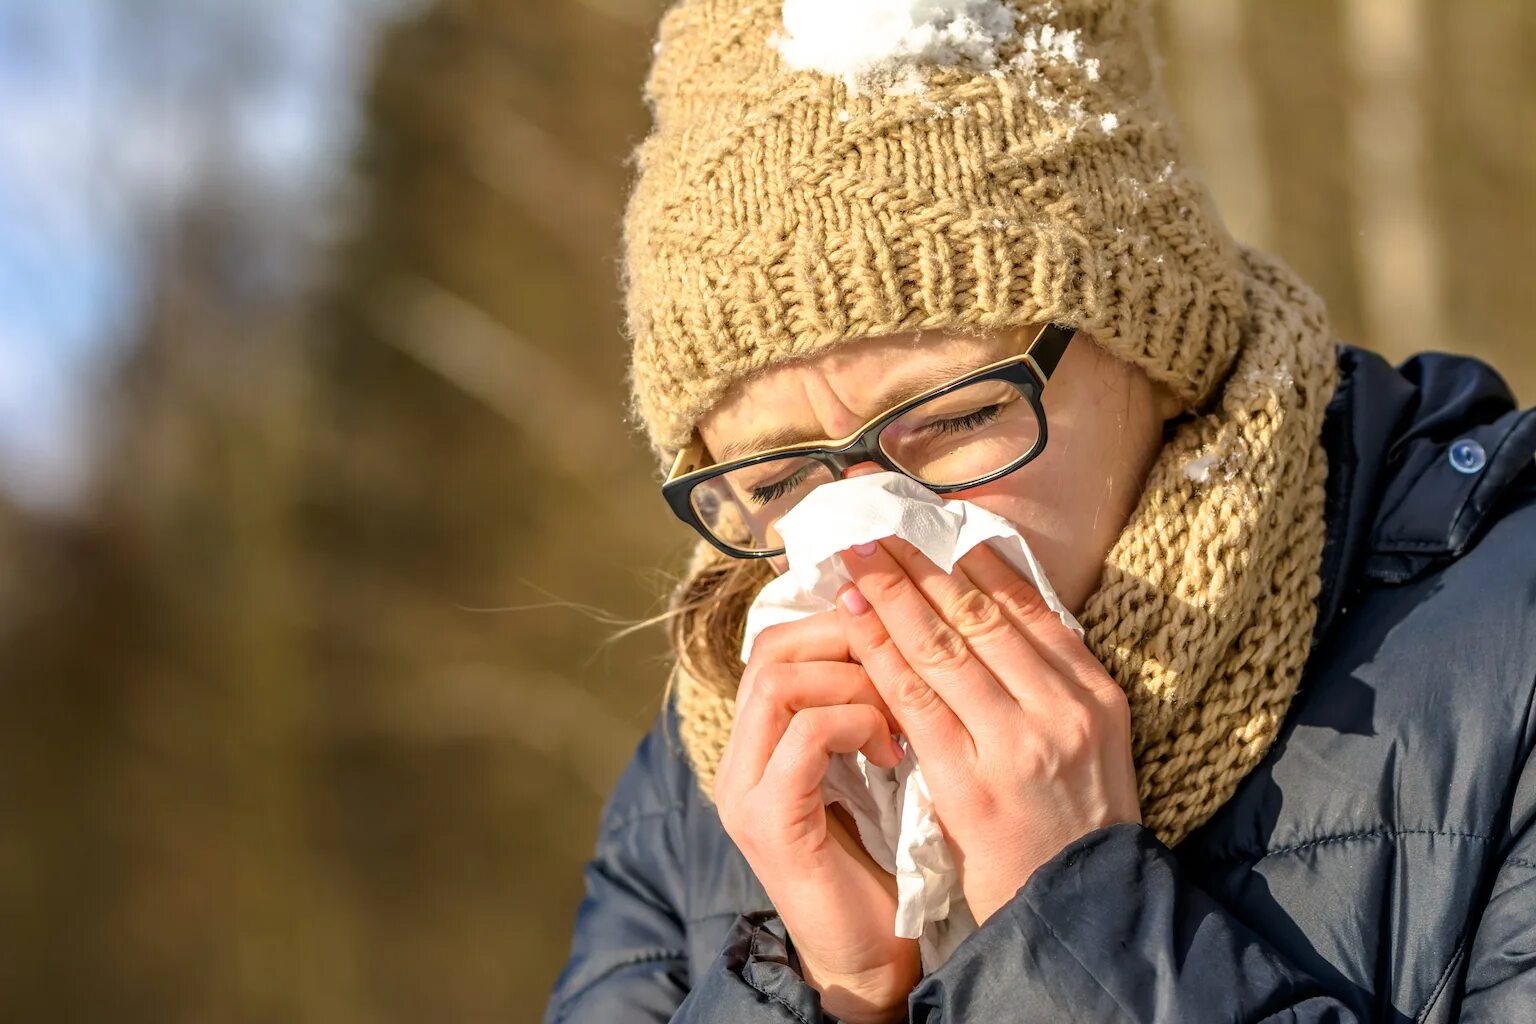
[{"xmin": 0, "ymin": 0, "xmax": 1536, "ymax": 1022}]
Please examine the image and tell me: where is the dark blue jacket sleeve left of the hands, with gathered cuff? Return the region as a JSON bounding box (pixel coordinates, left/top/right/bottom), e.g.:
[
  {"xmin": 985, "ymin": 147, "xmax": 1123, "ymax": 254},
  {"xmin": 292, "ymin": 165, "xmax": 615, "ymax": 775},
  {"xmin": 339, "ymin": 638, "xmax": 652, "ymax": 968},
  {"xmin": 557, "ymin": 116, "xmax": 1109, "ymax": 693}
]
[{"xmin": 542, "ymin": 705, "xmax": 836, "ymax": 1024}]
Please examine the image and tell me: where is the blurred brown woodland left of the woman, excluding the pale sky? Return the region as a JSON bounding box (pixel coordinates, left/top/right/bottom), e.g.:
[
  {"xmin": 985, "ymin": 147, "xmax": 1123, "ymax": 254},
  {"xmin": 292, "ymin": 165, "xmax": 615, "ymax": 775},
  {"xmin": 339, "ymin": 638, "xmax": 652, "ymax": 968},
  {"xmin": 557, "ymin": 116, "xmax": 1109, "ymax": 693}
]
[{"xmin": 0, "ymin": 3, "xmax": 688, "ymax": 1022}]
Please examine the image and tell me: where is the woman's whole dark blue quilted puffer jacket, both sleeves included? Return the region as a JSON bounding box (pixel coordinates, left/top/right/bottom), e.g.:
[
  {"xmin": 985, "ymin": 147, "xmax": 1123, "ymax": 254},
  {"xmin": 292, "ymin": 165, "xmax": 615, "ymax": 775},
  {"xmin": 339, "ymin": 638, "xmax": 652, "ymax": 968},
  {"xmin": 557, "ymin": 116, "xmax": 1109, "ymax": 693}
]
[{"xmin": 544, "ymin": 345, "xmax": 1536, "ymax": 1024}]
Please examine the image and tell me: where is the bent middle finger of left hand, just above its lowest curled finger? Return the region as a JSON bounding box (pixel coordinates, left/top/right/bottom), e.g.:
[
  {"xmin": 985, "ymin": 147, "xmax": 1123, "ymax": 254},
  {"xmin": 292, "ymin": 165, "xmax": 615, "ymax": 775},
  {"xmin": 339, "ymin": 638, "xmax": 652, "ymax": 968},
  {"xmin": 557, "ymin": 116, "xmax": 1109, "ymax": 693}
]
[{"xmin": 731, "ymin": 662, "xmax": 902, "ymax": 781}]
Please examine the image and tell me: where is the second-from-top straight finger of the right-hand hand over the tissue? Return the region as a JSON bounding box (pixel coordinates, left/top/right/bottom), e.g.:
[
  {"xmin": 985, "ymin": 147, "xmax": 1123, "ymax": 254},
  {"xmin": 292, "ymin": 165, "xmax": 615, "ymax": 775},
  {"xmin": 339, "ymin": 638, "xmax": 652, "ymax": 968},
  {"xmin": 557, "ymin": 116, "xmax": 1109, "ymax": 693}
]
[{"xmin": 886, "ymin": 537, "xmax": 1081, "ymax": 708}]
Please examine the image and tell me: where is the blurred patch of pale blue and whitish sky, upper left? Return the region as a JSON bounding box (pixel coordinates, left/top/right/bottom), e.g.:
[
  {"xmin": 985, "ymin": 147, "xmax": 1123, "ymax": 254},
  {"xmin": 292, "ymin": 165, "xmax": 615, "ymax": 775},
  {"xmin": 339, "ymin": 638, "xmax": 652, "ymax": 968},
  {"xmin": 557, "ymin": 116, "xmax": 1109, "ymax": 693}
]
[{"xmin": 0, "ymin": 0, "xmax": 404, "ymax": 508}]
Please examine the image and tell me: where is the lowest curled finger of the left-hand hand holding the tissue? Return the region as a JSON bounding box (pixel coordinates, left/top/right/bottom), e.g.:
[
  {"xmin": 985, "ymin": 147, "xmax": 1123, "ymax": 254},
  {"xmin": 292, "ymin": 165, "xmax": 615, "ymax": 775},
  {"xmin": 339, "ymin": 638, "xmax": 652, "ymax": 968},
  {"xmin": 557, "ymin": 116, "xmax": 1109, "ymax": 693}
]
[{"xmin": 762, "ymin": 705, "xmax": 897, "ymax": 824}]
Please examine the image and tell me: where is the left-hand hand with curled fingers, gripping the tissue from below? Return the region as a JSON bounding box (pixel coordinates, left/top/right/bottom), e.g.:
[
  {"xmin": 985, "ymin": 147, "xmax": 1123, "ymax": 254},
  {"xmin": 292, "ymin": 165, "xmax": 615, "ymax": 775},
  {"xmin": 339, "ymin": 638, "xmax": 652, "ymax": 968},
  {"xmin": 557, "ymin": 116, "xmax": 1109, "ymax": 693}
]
[{"xmin": 713, "ymin": 611, "xmax": 922, "ymax": 1024}]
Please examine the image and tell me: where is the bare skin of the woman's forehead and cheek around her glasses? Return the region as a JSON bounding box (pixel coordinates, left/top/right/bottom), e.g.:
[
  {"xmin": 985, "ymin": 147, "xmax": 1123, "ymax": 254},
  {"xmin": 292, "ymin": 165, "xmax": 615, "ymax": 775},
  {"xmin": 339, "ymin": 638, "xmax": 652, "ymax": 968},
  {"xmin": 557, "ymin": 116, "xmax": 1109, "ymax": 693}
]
[{"xmin": 699, "ymin": 327, "xmax": 1180, "ymax": 614}]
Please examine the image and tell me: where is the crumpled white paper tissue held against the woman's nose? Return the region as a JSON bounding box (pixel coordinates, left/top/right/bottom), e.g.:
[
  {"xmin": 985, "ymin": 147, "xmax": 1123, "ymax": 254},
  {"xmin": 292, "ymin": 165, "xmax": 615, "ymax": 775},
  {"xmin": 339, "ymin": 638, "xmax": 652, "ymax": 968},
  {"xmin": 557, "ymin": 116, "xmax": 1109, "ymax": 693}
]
[{"xmin": 742, "ymin": 471, "xmax": 1083, "ymax": 973}]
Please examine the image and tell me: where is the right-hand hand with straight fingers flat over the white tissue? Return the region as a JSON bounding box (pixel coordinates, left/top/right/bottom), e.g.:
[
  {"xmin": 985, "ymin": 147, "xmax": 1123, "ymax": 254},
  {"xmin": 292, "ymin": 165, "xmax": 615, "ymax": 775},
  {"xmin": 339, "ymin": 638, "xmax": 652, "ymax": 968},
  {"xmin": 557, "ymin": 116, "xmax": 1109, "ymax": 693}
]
[{"xmin": 837, "ymin": 537, "xmax": 1141, "ymax": 923}]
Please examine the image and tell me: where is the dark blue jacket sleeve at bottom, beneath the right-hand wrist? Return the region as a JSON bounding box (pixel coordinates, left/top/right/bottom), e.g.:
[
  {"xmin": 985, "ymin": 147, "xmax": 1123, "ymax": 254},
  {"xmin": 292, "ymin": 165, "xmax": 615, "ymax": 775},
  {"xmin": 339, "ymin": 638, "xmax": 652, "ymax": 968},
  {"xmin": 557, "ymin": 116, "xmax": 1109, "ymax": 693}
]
[{"xmin": 908, "ymin": 823, "xmax": 1366, "ymax": 1024}]
